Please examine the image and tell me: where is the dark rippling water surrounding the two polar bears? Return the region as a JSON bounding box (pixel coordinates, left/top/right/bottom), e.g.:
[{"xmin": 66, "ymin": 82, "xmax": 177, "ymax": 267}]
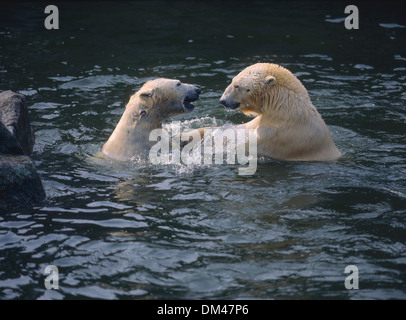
[{"xmin": 0, "ymin": 2, "xmax": 406, "ymax": 299}]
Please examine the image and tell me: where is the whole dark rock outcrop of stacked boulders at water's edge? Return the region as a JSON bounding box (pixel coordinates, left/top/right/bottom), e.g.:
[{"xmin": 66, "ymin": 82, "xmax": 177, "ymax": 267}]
[{"xmin": 0, "ymin": 91, "xmax": 45, "ymax": 213}]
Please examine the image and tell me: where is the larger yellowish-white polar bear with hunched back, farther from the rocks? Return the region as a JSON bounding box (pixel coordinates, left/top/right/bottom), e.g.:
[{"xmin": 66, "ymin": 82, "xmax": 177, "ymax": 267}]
[{"xmin": 211, "ymin": 63, "xmax": 342, "ymax": 161}]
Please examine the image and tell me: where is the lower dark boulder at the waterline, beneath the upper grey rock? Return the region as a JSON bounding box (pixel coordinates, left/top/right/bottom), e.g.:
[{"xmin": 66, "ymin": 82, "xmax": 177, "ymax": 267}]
[{"xmin": 0, "ymin": 154, "xmax": 45, "ymax": 213}]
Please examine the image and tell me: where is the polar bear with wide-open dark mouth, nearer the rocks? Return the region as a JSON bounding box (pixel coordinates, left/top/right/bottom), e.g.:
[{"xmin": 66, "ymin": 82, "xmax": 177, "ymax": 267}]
[{"xmin": 102, "ymin": 78, "xmax": 201, "ymax": 161}]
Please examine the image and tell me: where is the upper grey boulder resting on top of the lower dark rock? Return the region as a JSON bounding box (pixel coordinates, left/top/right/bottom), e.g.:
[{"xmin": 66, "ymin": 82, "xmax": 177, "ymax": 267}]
[{"xmin": 0, "ymin": 90, "xmax": 35, "ymax": 155}]
